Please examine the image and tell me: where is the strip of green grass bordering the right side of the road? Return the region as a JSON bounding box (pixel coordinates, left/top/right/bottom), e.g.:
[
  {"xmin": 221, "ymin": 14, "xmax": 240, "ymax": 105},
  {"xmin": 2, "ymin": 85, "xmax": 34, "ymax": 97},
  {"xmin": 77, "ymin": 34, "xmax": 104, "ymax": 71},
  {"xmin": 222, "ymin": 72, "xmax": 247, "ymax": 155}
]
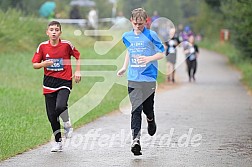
[{"xmin": 199, "ymin": 39, "xmax": 252, "ymax": 91}]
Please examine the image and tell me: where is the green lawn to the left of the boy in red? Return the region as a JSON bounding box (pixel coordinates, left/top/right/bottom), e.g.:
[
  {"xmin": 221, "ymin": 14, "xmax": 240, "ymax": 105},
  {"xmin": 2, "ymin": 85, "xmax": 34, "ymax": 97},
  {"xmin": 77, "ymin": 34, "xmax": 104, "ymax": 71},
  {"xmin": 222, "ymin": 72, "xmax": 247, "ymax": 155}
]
[{"xmin": 0, "ymin": 54, "xmax": 50, "ymax": 160}]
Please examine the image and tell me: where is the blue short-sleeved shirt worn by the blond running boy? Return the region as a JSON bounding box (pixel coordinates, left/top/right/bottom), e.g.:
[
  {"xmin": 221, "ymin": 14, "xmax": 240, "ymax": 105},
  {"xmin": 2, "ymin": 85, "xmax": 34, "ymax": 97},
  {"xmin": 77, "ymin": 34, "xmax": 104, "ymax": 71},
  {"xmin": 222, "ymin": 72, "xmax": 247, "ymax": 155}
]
[{"xmin": 123, "ymin": 28, "xmax": 164, "ymax": 82}]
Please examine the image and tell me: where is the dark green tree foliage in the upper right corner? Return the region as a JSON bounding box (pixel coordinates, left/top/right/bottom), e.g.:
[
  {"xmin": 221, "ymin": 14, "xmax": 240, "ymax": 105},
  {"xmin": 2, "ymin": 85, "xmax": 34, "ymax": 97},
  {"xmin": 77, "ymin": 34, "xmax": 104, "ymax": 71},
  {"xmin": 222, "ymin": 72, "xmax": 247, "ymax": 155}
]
[{"xmin": 205, "ymin": 0, "xmax": 252, "ymax": 59}]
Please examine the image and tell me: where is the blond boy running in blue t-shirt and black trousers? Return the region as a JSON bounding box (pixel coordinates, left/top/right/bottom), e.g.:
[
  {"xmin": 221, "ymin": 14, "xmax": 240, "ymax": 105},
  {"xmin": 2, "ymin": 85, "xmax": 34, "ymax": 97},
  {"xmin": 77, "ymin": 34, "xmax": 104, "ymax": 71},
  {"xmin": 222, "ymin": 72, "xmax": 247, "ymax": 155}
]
[{"xmin": 117, "ymin": 8, "xmax": 165, "ymax": 155}]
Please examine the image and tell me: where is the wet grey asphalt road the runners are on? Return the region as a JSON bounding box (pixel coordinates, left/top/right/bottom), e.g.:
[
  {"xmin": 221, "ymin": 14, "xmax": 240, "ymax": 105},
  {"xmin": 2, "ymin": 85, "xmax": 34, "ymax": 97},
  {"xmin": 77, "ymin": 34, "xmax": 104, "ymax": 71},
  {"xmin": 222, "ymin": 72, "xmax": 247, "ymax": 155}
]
[{"xmin": 0, "ymin": 49, "xmax": 252, "ymax": 167}]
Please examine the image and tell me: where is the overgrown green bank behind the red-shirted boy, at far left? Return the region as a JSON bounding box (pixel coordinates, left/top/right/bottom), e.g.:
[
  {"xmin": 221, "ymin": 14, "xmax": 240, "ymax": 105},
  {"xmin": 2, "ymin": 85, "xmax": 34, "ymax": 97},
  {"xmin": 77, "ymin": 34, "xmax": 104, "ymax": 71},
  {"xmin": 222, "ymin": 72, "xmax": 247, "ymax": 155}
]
[{"xmin": 0, "ymin": 9, "xmax": 47, "ymax": 53}]
